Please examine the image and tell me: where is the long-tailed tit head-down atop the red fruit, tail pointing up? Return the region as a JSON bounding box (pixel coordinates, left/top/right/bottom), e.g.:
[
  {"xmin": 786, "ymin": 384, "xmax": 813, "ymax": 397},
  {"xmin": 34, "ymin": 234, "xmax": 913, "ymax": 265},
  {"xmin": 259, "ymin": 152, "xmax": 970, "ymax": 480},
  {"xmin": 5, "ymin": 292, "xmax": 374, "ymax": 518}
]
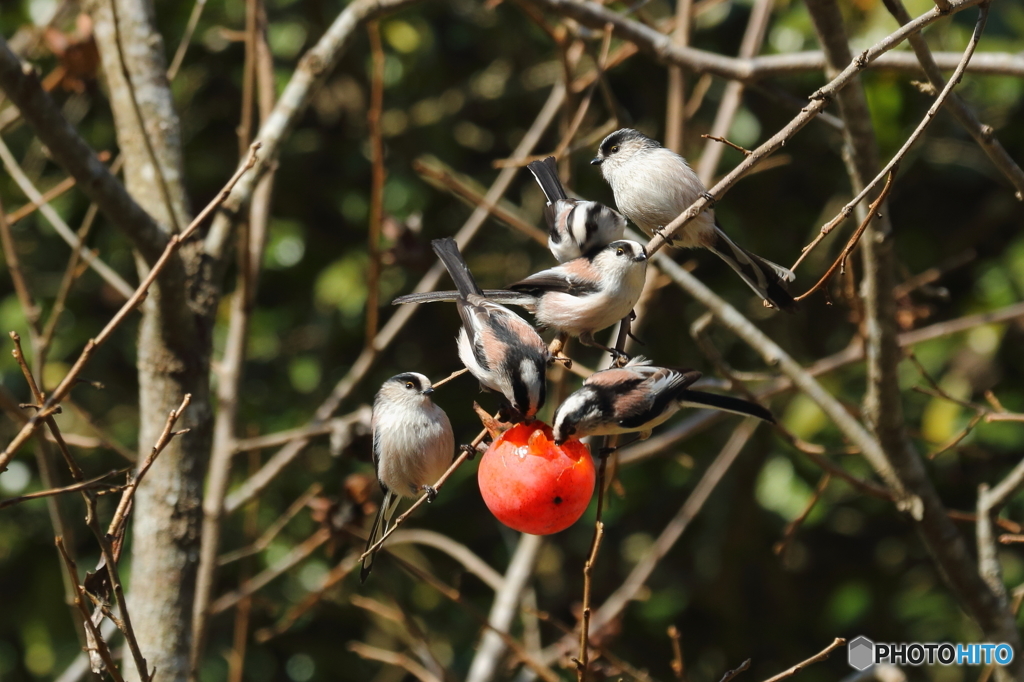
[{"xmin": 428, "ymin": 238, "xmax": 551, "ymax": 420}]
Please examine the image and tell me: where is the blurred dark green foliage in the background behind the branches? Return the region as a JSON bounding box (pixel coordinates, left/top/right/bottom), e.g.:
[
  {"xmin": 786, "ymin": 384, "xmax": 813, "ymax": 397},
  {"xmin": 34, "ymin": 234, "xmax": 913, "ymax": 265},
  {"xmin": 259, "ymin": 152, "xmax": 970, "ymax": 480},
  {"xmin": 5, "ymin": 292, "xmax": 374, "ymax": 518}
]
[{"xmin": 0, "ymin": 0, "xmax": 1024, "ymax": 682}]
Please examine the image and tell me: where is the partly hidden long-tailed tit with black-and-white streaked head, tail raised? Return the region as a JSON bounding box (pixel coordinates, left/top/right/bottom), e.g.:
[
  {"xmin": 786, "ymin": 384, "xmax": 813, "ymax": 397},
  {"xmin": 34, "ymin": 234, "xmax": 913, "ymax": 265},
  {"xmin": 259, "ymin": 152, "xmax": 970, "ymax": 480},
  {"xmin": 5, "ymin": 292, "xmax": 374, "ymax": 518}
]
[{"xmin": 526, "ymin": 157, "xmax": 626, "ymax": 263}]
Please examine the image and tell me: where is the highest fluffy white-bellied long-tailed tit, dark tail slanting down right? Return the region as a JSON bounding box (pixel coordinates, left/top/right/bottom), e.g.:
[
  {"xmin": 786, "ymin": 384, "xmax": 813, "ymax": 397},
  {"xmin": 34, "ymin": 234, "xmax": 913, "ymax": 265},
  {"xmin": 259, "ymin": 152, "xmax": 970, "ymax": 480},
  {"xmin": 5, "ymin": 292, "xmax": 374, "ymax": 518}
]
[{"xmin": 590, "ymin": 128, "xmax": 799, "ymax": 312}]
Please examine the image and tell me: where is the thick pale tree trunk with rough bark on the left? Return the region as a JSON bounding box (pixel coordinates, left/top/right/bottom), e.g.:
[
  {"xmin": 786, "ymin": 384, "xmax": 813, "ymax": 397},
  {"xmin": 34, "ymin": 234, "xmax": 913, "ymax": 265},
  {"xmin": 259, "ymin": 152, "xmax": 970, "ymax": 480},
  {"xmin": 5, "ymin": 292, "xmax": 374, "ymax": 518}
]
[{"xmin": 88, "ymin": 0, "xmax": 211, "ymax": 682}]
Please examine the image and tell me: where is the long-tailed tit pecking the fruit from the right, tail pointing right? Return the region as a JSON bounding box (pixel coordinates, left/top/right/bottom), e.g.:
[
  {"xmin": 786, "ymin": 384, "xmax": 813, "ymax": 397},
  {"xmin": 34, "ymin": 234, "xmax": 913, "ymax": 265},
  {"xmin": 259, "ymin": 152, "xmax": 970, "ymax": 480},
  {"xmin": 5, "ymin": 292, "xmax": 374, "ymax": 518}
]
[{"xmin": 553, "ymin": 356, "xmax": 775, "ymax": 444}]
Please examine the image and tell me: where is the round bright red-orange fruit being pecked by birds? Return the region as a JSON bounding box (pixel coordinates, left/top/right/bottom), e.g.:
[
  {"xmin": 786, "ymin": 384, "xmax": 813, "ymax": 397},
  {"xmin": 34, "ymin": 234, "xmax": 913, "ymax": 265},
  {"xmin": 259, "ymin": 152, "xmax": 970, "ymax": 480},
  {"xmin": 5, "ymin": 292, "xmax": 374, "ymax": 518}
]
[{"xmin": 476, "ymin": 421, "xmax": 596, "ymax": 536}]
